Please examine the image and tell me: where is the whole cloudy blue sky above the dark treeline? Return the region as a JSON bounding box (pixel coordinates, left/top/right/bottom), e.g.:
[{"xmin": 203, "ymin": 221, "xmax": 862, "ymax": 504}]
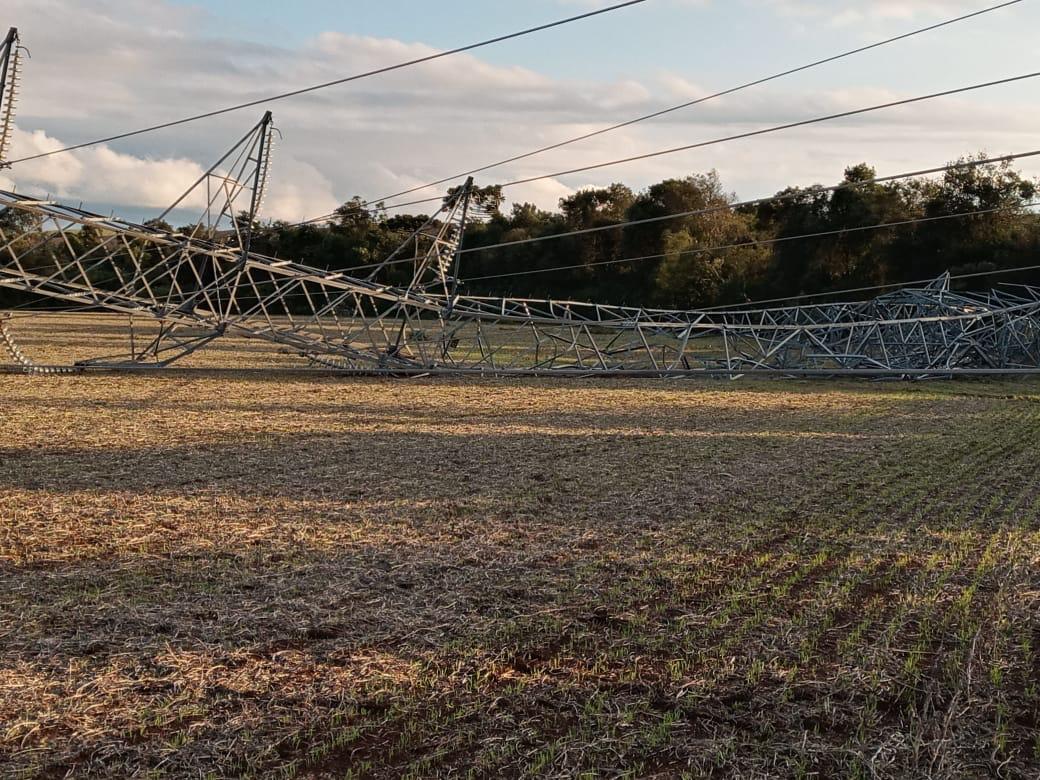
[{"xmin": 0, "ymin": 0, "xmax": 1040, "ymax": 220}]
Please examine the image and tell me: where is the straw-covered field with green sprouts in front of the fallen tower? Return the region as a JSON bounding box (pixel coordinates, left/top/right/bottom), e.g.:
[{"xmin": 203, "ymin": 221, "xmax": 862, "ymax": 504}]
[{"xmin": 0, "ymin": 345, "xmax": 1040, "ymax": 778}]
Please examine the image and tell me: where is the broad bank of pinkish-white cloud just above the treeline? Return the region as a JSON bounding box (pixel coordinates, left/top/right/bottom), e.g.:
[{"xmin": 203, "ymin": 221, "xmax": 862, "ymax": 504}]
[{"xmin": 0, "ymin": 0, "xmax": 1040, "ymax": 225}]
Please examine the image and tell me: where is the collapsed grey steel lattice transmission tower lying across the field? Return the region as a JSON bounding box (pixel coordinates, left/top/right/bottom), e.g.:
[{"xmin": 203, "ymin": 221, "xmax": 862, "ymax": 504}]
[{"xmin": 0, "ymin": 31, "xmax": 1040, "ymax": 376}]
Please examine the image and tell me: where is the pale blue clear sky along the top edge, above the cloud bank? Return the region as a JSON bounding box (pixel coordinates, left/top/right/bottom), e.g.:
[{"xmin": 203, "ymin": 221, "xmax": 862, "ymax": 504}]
[{"xmin": 172, "ymin": 0, "xmax": 1040, "ymax": 92}]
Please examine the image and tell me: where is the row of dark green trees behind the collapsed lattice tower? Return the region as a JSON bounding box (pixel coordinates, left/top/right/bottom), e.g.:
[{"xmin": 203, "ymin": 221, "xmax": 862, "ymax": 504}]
[{"xmin": 0, "ymin": 157, "xmax": 1040, "ymax": 308}]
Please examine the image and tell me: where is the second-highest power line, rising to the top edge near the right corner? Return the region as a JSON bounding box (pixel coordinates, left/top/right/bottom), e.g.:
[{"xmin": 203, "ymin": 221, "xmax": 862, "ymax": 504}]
[{"xmin": 368, "ymin": 0, "xmax": 1022, "ymax": 208}]
